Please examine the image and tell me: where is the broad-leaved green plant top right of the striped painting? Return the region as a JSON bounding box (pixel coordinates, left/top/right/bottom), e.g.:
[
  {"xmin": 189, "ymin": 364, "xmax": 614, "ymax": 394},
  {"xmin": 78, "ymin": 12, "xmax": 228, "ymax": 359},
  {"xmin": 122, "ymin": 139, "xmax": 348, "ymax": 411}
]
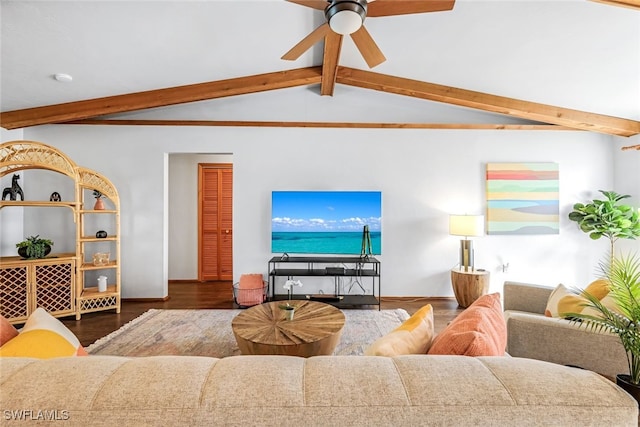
[{"xmin": 569, "ymin": 190, "xmax": 640, "ymax": 262}]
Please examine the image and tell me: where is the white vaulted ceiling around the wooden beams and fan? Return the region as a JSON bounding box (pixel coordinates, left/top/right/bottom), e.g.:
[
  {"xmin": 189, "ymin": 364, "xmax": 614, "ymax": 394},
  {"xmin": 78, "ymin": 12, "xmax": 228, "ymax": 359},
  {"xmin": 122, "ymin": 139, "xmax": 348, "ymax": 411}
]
[{"xmin": 0, "ymin": 0, "xmax": 640, "ymax": 131}]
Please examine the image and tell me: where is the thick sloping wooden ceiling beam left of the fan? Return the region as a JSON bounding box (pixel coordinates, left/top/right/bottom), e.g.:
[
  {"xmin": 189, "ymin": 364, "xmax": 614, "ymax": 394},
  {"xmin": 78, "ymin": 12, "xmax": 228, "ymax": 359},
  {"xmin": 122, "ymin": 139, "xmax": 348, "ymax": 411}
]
[{"xmin": 0, "ymin": 67, "xmax": 322, "ymax": 129}]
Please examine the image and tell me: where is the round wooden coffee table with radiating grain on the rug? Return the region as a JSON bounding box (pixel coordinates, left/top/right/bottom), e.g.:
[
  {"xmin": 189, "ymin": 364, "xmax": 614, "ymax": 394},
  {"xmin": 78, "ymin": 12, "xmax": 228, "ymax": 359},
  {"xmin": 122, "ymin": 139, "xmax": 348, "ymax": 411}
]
[{"xmin": 231, "ymin": 300, "xmax": 344, "ymax": 357}]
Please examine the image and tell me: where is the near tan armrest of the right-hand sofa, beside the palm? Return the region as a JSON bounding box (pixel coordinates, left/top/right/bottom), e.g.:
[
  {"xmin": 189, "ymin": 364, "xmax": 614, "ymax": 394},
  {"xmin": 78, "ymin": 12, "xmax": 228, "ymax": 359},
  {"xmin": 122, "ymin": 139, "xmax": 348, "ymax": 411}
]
[{"xmin": 505, "ymin": 311, "xmax": 629, "ymax": 379}]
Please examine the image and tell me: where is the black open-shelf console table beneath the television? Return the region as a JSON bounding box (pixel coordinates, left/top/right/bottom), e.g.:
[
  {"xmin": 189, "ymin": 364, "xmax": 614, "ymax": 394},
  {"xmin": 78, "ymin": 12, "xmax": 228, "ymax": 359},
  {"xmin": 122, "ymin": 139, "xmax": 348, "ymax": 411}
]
[{"xmin": 268, "ymin": 255, "xmax": 380, "ymax": 310}]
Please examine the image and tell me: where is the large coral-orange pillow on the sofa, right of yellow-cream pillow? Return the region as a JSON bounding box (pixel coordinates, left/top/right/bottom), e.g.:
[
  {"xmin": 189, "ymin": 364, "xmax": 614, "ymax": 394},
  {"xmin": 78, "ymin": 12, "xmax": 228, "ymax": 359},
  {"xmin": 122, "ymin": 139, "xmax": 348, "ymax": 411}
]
[{"xmin": 427, "ymin": 293, "xmax": 507, "ymax": 356}]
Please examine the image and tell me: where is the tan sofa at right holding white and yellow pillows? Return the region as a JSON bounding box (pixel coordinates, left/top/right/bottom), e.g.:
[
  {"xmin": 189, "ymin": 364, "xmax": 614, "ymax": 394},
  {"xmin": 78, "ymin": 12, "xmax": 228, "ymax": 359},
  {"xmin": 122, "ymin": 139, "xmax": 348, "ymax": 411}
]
[{"xmin": 503, "ymin": 281, "xmax": 629, "ymax": 379}]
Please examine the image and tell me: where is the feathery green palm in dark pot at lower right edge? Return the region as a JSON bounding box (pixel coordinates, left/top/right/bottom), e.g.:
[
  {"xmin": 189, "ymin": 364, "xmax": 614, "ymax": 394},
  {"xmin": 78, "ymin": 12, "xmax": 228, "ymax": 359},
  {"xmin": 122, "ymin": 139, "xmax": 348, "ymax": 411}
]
[{"xmin": 565, "ymin": 254, "xmax": 640, "ymax": 401}]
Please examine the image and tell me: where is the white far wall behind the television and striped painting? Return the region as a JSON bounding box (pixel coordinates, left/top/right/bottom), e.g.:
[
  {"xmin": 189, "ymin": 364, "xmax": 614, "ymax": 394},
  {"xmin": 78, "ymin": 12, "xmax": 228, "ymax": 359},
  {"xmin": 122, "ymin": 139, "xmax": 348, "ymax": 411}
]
[{"xmin": 13, "ymin": 126, "xmax": 637, "ymax": 298}]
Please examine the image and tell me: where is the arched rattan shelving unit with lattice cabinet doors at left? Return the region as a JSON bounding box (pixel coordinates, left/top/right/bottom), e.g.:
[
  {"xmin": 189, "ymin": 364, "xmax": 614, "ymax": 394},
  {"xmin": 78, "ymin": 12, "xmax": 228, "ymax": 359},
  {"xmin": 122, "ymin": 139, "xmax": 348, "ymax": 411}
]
[{"xmin": 0, "ymin": 141, "xmax": 121, "ymax": 323}]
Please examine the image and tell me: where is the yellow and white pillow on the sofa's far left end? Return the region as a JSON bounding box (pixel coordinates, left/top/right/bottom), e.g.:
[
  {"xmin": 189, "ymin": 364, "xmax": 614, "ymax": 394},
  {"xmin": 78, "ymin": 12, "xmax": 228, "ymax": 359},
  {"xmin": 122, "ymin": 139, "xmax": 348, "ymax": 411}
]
[{"xmin": 0, "ymin": 307, "xmax": 87, "ymax": 359}]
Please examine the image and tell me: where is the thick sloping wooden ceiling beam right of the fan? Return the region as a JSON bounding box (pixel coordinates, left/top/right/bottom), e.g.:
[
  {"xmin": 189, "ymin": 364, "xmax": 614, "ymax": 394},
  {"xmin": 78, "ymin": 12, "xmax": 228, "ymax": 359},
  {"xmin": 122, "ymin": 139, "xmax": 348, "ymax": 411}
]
[{"xmin": 336, "ymin": 67, "xmax": 640, "ymax": 137}]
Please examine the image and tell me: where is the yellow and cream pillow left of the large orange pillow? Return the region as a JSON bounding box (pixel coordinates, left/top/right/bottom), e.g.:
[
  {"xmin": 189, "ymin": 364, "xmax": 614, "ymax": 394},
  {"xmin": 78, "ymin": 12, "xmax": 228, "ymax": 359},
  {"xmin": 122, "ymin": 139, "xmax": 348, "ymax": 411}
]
[{"xmin": 364, "ymin": 304, "xmax": 434, "ymax": 357}]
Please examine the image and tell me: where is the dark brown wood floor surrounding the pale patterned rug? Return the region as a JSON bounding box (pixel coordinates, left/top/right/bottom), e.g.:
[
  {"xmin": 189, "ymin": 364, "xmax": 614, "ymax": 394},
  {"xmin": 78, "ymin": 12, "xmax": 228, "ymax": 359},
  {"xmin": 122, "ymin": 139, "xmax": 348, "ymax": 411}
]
[{"xmin": 60, "ymin": 282, "xmax": 462, "ymax": 347}]
